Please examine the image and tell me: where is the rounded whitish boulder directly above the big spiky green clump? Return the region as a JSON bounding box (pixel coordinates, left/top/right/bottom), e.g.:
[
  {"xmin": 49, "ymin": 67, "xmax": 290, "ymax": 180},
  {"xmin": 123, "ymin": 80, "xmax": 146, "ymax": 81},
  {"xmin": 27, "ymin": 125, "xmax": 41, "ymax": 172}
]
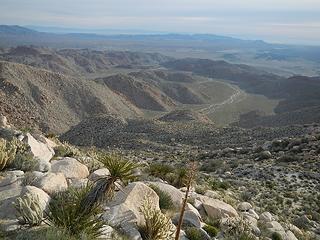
[{"xmin": 35, "ymin": 173, "xmax": 68, "ymax": 194}]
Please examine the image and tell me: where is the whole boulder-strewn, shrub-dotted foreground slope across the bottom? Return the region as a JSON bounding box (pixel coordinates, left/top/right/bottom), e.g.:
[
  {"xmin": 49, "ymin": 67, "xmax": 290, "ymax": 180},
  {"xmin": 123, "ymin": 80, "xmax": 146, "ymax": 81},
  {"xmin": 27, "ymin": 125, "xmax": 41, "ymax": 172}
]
[{"xmin": 0, "ymin": 116, "xmax": 320, "ymax": 240}]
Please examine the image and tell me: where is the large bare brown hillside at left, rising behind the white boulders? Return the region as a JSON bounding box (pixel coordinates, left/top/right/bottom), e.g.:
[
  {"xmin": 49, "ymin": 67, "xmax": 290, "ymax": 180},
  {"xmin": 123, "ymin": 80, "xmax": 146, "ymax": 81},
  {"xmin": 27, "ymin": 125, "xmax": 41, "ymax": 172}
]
[{"xmin": 0, "ymin": 62, "xmax": 141, "ymax": 132}]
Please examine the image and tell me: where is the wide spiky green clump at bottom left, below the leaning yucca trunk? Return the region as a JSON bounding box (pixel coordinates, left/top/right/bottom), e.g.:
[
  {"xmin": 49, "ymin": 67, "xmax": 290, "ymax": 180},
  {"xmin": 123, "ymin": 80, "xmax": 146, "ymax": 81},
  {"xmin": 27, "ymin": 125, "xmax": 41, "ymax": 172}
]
[{"xmin": 48, "ymin": 186, "xmax": 104, "ymax": 238}]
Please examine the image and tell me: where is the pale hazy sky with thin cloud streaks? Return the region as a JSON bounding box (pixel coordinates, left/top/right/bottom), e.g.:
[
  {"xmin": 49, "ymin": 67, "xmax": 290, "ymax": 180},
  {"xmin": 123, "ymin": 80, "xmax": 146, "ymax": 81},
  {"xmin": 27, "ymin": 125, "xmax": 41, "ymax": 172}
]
[{"xmin": 0, "ymin": 0, "xmax": 320, "ymax": 45}]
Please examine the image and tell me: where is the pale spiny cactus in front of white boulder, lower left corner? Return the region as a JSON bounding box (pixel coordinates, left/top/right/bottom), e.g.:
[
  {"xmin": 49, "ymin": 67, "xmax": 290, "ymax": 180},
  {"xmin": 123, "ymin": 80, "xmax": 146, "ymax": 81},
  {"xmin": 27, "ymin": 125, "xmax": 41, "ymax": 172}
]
[{"xmin": 14, "ymin": 193, "xmax": 43, "ymax": 226}]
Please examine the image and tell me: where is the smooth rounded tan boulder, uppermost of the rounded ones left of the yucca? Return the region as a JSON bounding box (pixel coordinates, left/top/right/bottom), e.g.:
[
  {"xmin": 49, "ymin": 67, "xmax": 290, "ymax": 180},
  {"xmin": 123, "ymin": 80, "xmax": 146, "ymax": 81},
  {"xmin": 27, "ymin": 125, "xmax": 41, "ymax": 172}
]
[{"xmin": 51, "ymin": 157, "xmax": 89, "ymax": 179}]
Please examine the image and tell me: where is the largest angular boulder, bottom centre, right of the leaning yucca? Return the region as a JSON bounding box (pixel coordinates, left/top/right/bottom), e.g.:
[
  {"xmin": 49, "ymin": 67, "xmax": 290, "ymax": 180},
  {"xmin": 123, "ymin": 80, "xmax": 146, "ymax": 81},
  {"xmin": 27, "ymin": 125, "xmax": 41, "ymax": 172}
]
[{"xmin": 103, "ymin": 182, "xmax": 160, "ymax": 240}]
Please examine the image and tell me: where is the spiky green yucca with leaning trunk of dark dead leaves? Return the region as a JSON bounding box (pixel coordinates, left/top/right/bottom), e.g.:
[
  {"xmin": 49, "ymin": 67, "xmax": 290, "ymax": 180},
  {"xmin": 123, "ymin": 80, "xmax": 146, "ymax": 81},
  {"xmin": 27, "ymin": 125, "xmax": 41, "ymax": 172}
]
[{"xmin": 83, "ymin": 154, "xmax": 140, "ymax": 209}]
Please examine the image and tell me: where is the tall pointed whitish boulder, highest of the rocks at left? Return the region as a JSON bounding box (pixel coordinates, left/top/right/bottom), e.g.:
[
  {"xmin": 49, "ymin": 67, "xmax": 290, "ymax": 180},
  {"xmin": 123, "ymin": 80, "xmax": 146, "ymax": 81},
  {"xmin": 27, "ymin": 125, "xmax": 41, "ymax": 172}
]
[{"xmin": 23, "ymin": 133, "xmax": 54, "ymax": 172}]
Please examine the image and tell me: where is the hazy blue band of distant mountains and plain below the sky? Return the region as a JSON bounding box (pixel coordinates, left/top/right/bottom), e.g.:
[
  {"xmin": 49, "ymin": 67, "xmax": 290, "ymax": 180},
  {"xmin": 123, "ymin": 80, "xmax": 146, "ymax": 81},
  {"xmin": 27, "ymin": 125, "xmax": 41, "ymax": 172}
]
[{"xmin": 0, "ymin": 25, "xmax": 320, "ymax": 76}]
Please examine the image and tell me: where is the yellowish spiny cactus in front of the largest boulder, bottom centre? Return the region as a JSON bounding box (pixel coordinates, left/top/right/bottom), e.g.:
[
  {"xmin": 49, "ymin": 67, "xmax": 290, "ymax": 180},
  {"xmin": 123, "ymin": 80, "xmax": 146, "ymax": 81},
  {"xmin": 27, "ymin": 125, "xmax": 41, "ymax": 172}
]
[{"xmin": 139, "ymin": 198, "xmax": 174, "ymax": 240}]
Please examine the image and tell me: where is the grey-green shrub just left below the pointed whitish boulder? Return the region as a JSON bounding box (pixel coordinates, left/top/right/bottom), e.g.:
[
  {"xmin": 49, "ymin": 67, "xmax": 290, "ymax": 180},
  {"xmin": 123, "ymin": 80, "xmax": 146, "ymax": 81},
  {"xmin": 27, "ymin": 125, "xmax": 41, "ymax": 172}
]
[{"xmin": 10, "ymin": 152, "xmax": 38, "ymax": 172}]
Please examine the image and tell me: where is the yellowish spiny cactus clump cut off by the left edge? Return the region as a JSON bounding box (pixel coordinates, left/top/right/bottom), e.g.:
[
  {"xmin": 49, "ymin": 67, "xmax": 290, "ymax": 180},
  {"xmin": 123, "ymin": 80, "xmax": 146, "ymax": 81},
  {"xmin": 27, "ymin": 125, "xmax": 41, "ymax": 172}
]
[{"xmin": 0, "ymin": 138, "xmax": 17, "ymax": 171}]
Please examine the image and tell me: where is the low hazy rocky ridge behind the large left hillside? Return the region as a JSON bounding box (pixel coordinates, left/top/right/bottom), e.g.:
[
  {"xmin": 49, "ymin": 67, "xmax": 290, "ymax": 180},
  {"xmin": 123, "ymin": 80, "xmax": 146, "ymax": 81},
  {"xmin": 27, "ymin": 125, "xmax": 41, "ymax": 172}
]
[{"xmin": 0, "ymin": 46, "xmax": 170, "ymax": 76}]
